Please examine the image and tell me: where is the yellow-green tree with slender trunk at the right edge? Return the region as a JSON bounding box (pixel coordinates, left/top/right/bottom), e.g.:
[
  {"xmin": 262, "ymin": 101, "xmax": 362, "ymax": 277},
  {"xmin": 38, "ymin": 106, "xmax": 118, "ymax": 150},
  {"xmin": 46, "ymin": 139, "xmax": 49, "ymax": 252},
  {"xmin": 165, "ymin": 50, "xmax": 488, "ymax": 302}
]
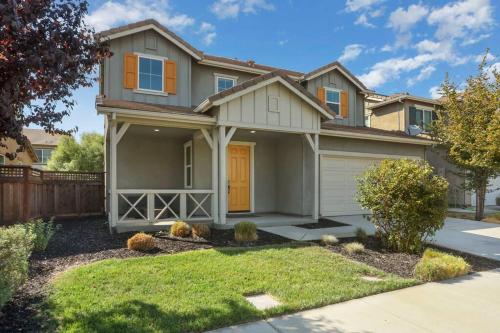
[{"xmin": 433, "ymin": 56, "xmax": 500, "ymax": 220}]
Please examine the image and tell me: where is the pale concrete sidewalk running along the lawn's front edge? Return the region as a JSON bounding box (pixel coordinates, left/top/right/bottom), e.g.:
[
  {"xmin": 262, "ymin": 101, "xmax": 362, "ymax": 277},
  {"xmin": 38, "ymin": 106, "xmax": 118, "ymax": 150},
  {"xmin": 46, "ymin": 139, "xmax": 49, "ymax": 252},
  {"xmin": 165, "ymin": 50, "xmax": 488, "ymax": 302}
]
[{"xmin": 212, "ymin": 270, "xmax": 500, "ymax": 333}]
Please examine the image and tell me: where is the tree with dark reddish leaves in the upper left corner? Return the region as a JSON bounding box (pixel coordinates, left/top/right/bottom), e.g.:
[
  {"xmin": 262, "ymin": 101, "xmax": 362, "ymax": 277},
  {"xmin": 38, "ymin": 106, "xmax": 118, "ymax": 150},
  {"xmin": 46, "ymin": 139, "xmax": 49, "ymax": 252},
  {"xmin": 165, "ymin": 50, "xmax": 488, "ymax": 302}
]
[{"xmin": 0, "ymin": 0, "xmax": 110, "ymax": 158}]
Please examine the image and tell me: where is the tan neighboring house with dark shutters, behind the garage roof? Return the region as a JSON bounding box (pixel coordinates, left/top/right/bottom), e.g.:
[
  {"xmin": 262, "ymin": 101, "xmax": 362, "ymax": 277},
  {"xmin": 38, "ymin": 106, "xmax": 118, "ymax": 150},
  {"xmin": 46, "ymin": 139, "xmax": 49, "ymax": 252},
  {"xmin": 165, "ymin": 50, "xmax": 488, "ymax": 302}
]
[{"xmin": 368, "ymin": 93, "xmax": 471, "ymax": 206}]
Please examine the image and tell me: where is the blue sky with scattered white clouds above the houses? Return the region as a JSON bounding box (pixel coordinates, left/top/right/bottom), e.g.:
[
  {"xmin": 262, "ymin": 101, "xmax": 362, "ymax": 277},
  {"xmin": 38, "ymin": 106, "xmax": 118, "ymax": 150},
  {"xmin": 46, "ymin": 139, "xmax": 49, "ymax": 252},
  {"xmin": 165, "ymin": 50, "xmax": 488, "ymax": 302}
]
[{"xmin": 57, "ymin": 0, "xmax": 500, "ymax": 133}]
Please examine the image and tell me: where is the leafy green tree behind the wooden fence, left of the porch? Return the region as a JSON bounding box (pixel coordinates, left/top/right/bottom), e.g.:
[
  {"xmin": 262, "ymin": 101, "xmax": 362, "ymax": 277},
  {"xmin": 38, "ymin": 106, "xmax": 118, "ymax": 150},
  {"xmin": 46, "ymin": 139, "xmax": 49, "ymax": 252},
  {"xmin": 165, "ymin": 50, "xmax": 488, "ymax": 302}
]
[{"xmin": 47, "ymin": 133, "xmax": 104, "ymax": 172}]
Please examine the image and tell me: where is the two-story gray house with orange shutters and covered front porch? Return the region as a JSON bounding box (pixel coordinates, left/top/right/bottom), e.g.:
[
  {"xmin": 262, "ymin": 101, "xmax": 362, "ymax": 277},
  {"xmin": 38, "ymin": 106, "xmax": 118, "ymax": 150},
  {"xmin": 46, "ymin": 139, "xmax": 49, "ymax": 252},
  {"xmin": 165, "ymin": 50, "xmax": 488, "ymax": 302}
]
[{"xmin": 96, "ymin": 20, "xmax": 433, "ymax": 231}]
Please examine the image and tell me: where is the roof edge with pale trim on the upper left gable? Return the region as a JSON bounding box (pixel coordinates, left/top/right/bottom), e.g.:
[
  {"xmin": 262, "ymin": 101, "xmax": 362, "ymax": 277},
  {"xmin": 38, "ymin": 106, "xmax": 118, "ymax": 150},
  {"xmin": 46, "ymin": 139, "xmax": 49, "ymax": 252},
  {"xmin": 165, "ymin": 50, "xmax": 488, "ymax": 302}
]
[{"xmin": 96, "ymin": 19, "xmax": 203, "ymax": 60}]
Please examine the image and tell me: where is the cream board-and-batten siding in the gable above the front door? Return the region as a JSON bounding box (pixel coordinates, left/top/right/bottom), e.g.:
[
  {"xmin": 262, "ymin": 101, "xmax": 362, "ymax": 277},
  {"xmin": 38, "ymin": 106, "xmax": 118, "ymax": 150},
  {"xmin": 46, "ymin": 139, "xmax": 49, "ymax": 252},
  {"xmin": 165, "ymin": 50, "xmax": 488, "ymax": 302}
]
[{"xmin": 219, "ymin": 82, "xmax": 320, "ymax": 132}]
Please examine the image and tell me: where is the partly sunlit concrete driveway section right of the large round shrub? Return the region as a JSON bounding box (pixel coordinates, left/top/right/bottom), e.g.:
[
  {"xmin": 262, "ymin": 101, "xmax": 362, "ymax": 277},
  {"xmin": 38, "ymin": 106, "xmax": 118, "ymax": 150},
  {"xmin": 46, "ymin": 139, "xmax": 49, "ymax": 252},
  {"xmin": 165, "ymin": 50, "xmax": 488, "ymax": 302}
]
[{"xmin": 433, "ymin": 217, "xmax": 500, "ymax": 260}]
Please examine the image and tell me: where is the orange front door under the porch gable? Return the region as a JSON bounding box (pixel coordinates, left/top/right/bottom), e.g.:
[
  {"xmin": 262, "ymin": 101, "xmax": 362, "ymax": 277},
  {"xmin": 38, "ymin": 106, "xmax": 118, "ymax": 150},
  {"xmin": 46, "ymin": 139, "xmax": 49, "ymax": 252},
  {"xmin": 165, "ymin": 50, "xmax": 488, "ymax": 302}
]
[{"xmin": 227, "ymin": 145, "xmax": 250, "ymax": 212}]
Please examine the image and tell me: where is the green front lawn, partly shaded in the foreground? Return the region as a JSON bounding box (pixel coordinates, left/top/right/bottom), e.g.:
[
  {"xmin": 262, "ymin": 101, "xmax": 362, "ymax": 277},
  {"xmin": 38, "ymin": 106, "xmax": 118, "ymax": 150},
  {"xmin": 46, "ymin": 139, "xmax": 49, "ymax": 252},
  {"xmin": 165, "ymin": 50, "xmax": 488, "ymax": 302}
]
[{"xmin": 48, "ymin": 246, "xmax": 418, "ymax": 332}]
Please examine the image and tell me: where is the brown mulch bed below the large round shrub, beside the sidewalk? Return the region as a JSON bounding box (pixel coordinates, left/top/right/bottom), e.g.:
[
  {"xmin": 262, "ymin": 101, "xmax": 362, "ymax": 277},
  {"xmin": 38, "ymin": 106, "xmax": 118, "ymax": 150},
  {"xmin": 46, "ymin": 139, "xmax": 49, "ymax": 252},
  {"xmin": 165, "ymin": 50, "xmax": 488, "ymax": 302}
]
[{"xmin": 326, "ymin": 237, "xmax": 500, "ymax": 278}]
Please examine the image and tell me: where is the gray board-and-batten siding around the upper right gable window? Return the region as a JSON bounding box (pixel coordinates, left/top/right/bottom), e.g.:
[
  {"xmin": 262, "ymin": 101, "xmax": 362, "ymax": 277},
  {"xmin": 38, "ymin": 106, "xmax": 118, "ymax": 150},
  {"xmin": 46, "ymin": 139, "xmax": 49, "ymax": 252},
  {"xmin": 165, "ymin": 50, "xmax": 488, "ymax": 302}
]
[{"xmin": 306, "ymin": 69, "xmax": 364, "ymax": 126}]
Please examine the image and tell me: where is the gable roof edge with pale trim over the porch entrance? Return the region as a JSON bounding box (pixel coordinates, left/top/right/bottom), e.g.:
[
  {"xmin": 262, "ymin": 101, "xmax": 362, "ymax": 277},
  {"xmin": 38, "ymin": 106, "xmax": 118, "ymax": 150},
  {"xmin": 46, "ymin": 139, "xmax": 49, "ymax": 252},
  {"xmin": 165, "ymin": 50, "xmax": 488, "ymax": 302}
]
[{"xmin": 194, "ymin": 70, "xmax": 335, "ymax": 119}]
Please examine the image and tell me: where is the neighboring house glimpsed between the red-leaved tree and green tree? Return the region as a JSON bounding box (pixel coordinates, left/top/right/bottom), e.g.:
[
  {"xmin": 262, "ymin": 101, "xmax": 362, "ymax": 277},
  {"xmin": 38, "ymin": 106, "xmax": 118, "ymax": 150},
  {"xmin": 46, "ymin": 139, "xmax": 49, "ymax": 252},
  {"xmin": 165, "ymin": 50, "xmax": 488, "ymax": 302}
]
[{"xmin": 23, "ymin": 128, "xmax": 63, "ymax": 169}]
